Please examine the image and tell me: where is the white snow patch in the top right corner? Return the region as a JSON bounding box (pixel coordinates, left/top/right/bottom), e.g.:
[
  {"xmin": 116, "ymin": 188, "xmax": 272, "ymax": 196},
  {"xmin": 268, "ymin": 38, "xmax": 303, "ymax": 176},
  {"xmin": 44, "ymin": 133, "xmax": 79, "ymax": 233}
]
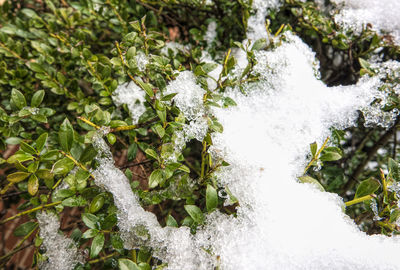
[{"xmin": 333, "ymin": 0, "xmax": 400, "ymax": 44}]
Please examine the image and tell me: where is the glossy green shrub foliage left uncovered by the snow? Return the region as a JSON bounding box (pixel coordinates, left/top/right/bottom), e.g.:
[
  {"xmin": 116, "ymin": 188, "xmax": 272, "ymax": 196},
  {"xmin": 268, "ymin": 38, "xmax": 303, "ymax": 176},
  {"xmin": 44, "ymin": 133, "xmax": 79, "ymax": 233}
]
[{"xmin": 0, "ymin": 0, "xmax": 400, "ymax": 270}]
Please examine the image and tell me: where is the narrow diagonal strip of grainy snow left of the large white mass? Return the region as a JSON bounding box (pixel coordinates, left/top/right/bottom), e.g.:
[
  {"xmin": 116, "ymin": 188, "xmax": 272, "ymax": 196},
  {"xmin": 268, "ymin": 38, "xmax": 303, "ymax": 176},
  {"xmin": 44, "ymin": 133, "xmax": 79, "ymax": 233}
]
[{"xmin": 93, "ymin": 135, "xmax": 214, "ymax": 270}]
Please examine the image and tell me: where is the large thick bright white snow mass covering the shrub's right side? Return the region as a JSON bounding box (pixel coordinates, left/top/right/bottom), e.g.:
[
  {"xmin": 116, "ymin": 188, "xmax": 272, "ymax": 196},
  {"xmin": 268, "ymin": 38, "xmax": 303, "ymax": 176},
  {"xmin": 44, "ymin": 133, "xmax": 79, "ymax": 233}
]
[{"xmin": 204, "ymin": 36, "xmax": 400, "ymax": 269}]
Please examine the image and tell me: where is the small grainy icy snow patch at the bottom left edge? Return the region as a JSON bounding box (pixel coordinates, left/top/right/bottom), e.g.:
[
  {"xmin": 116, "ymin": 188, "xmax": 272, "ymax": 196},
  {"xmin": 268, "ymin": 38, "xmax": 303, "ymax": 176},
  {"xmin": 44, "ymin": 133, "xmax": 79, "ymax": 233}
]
[{"xmin": 36, "ymin": 211, "xmax": 83, "ymax": 270}]
